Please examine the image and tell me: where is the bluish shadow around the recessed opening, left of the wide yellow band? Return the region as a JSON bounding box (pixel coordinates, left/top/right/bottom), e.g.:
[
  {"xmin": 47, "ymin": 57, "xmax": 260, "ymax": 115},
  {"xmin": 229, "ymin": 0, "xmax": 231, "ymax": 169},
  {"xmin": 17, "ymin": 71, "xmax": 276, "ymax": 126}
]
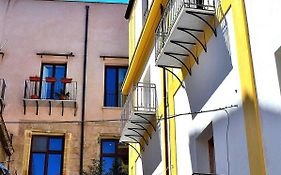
[{"xmin": 189, "ymin": 104, "xmax": 249, "ymax": 174}]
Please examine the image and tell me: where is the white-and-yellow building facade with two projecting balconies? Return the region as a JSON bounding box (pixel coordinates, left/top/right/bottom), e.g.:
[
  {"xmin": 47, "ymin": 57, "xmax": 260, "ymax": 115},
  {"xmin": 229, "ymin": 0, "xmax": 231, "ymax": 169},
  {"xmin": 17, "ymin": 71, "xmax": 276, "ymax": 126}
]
[{"xmin": 120, "ymin": 0, "xmax": 281, "ymax": 175}]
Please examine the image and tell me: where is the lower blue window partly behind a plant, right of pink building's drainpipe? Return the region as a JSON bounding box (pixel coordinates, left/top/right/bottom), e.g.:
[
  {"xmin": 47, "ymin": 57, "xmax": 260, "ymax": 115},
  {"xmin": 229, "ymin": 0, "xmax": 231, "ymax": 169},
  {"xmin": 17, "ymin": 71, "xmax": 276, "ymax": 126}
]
[{"xmin": 101, "ymin": 139, "xmax": 128, "ymax": 175}]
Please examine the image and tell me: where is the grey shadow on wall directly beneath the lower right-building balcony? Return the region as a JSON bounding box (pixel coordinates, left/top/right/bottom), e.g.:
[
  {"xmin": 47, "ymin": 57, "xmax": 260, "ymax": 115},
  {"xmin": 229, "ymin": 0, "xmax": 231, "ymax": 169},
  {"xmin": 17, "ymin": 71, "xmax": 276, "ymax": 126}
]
[{"xmin": 142, "ymin": 123, "xmax": 162, "ymax": 174}]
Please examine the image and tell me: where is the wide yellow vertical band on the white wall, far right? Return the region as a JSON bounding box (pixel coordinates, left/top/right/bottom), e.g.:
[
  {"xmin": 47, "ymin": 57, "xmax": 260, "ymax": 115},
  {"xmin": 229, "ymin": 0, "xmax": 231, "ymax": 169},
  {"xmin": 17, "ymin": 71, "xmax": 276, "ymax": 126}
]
[{"xmin": 231, "ymin": 0, "xmax": 266, "ymax": 175}]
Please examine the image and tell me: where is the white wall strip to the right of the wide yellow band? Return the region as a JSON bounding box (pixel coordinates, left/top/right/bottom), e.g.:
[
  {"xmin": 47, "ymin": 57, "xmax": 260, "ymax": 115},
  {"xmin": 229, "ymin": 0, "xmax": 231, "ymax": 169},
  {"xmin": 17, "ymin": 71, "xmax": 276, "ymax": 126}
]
[{"xmin": 245, "ymin": 0, "xmax": 281, "ymax": 174}]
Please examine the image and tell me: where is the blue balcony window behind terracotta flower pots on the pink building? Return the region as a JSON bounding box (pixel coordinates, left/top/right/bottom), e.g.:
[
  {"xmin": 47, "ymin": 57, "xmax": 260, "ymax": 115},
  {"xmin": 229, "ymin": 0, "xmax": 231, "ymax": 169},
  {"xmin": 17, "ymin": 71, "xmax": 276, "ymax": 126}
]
[{"xmin": 41, "ymin": 63, "xmax": 66, "ymax": 99}]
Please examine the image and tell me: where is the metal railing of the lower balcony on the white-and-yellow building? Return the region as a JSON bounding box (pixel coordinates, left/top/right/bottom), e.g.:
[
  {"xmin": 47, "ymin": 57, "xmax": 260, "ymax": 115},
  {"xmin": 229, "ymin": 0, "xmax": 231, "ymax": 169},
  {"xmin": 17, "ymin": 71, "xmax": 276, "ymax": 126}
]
[{"xmin": 121, "ymin": 83, "xmax": 157, "ymax": 131}]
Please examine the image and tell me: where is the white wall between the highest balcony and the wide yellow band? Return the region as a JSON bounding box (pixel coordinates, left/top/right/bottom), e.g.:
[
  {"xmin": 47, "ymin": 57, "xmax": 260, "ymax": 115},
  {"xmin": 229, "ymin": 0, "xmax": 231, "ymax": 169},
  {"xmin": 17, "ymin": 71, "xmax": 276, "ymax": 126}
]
[{"xmin": 175, "ymin": 10, "xmax": 249, "ymax": 175}]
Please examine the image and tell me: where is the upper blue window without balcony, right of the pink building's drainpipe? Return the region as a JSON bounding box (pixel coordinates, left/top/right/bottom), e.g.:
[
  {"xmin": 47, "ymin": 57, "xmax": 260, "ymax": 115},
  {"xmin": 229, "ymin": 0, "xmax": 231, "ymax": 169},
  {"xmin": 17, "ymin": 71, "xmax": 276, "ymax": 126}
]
[{"xmin": 104, "ymin": 66, "xmax": 128, "ymax": 107}]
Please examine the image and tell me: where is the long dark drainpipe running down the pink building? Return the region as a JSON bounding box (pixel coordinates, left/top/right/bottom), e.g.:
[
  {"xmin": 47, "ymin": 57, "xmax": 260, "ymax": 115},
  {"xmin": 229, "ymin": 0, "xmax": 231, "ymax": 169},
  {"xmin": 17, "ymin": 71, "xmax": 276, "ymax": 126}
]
[{"xmin": 80, "ymin": 6, "xmax": 89, "ymax": 175}]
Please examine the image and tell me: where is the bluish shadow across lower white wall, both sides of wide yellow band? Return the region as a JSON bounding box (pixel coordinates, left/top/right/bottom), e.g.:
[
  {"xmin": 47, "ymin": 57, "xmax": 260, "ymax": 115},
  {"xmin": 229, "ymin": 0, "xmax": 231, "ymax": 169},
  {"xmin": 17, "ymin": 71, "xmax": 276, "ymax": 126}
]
[{"xmin": 186, "ymin": 96, "xmax": 281, "ymax": 174}]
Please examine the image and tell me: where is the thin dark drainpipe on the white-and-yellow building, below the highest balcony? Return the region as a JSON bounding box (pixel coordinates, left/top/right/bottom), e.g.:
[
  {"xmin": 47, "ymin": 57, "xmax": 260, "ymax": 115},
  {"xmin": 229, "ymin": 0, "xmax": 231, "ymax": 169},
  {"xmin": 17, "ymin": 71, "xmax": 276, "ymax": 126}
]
[{"xmin": 163, "ymin": 68, "xmax": 170, "ymax": 175}]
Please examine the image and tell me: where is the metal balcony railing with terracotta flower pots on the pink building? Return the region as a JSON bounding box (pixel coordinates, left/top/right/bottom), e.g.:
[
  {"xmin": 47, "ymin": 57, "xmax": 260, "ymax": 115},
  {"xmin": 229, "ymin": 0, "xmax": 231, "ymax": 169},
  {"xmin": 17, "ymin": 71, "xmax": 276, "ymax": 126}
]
[{"xmin": 24, "ymin": 80, "xmax": 77, "ymax": 100}]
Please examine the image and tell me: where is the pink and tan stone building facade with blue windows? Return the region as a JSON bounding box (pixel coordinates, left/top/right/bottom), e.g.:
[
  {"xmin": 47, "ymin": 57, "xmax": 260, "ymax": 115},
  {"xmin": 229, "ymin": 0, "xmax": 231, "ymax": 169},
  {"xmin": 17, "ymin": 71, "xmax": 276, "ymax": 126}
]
[{"xmin": 0, "ymin": 0, "xmax": 128, "ymax": 175}]
